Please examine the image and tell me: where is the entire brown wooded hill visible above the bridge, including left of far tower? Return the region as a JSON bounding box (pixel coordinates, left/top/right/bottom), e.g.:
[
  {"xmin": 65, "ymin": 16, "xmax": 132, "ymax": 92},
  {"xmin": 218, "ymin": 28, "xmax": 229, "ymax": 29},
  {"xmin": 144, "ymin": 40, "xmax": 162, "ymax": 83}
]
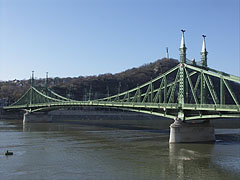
[{"xmin": 0, "ymin": 58, "xmax": 178, "ymax": 103}]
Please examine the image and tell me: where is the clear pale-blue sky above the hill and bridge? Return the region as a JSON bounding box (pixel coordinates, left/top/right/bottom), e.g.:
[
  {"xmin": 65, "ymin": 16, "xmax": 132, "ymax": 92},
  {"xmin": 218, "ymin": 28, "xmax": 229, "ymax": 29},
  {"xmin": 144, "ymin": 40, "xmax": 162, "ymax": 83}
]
[{"xmin": 0, "ymin": 0, "xmax": 240, "ymax": 80}]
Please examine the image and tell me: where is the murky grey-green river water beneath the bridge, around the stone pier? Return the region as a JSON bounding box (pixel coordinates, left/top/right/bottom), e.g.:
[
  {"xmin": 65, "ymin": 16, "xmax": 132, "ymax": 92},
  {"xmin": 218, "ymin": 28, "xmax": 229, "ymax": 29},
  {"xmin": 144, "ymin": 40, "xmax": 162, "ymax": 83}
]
[{"xmin": 0, "ymin": 120, "xmax": 240, "ymax": 180}]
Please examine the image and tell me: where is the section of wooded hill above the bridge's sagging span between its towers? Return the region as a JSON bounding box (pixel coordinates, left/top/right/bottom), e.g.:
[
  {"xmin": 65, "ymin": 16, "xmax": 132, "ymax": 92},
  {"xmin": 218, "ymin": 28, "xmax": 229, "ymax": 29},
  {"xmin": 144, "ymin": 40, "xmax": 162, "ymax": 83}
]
[{"xmin": 50, "ymin": 58, "xmax": 178, "ymax": 100}]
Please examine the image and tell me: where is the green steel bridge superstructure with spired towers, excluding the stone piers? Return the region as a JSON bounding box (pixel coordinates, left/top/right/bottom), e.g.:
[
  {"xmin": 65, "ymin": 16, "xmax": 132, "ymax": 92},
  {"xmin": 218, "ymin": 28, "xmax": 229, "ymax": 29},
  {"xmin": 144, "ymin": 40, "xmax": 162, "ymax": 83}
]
[{"xmin": 4, "ymin": 30, "xmax": 240, "ymax": 121}]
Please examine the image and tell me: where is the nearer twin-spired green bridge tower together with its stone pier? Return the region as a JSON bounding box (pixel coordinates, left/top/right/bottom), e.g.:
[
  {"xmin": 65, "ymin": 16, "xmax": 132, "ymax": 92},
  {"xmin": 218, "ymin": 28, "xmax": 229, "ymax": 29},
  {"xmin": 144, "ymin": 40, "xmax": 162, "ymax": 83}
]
[{"xmin": 169, "ymin": 30, "xmax": 215, "ymax": 143}]
